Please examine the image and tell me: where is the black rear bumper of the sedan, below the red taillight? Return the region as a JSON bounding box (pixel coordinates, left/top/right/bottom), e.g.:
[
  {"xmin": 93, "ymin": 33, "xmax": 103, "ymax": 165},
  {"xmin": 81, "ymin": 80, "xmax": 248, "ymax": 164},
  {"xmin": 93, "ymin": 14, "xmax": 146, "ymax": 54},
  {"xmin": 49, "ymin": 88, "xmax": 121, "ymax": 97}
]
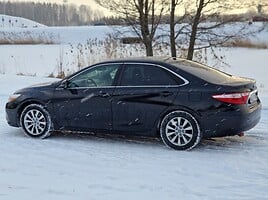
[{"xmin": 200, "ymin": 103, "xmax": 262, "ymax": 138}]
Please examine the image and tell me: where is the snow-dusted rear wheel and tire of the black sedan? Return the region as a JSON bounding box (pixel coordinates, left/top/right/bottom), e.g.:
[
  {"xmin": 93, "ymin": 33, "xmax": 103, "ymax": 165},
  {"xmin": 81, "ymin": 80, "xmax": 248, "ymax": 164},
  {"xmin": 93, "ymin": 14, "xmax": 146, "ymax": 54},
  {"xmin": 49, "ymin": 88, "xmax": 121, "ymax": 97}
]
[{"xmin": 160, "ymin": 110, "xmax": 202, "ymax": 150}]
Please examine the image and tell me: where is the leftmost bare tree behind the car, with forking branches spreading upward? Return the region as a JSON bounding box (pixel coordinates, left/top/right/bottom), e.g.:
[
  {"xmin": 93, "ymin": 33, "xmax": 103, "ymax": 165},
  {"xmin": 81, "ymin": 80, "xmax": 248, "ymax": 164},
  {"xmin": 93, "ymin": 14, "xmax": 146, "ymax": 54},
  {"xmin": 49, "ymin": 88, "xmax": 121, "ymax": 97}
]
[{"xmin": 96, "ymin": 0, "xmax": 168, "ymax": 56}]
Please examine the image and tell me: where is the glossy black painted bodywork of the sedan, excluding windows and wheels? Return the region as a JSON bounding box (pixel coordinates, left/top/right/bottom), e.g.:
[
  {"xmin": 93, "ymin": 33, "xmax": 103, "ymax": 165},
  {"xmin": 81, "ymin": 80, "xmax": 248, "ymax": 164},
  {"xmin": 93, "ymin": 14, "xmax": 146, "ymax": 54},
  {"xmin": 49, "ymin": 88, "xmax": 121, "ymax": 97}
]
[{"xmin": 6, "ymin": 60, "xmax": 261, "ymax": 137}]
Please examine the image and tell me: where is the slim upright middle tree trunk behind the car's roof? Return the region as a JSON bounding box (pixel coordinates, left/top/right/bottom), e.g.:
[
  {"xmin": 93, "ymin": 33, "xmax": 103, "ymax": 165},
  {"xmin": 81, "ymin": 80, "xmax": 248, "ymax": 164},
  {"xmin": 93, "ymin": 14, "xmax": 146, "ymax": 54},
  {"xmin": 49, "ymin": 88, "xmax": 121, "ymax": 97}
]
[{"xmin": 169, "ymin": 0, "xmax": 177, "ymax": 57}]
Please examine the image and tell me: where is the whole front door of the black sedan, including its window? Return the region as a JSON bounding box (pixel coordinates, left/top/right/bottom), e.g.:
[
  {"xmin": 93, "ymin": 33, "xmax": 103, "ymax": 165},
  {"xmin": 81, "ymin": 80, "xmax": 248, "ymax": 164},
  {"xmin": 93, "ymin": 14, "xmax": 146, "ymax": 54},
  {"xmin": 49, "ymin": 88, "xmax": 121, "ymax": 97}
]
[{"xmin": 54, "ymin": 64, "xmax": 120, "ymax": 130}]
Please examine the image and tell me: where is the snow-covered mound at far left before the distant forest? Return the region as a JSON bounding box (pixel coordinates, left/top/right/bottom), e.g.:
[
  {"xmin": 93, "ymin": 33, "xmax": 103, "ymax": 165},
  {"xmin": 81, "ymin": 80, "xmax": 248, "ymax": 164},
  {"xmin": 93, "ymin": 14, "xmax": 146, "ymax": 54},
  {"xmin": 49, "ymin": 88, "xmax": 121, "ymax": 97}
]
[{"xmin": 0, "ymin": 15, "xmax": 46, "ymax": 28}]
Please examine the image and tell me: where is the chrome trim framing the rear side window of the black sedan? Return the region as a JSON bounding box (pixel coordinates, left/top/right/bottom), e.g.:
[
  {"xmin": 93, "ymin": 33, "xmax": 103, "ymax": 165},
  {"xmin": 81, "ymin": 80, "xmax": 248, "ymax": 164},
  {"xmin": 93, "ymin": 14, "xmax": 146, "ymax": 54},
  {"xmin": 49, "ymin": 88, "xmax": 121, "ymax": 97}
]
[{"xmin": 116, "ymin": 62, "xmax": 189, "ymax": 88}]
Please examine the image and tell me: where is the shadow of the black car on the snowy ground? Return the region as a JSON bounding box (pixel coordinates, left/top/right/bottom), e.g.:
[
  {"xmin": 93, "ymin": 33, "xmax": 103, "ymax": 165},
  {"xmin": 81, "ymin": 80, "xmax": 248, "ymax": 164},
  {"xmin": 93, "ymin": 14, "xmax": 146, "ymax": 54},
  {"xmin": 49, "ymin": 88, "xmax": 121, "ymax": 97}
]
[{"xmin": 2, "ymin": 129, "xmax": 268, "ymax": 151}]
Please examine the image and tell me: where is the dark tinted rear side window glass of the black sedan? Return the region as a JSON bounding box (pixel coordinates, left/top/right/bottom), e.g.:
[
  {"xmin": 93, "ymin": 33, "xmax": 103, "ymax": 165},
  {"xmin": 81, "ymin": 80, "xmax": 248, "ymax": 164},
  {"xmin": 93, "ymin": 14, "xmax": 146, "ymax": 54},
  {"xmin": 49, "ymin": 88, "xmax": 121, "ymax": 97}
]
[{"xmin": 121, "ymin": 64, "xmax": 181, "ymax": 86}]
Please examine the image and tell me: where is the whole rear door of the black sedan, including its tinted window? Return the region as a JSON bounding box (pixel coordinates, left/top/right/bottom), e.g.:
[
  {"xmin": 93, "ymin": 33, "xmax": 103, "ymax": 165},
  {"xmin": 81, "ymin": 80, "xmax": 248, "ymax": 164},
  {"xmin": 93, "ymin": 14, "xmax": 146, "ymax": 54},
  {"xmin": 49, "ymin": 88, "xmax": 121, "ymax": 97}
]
[{"xmin": 112, "ymin": 63, "xmax": 184, "ymax": 134}]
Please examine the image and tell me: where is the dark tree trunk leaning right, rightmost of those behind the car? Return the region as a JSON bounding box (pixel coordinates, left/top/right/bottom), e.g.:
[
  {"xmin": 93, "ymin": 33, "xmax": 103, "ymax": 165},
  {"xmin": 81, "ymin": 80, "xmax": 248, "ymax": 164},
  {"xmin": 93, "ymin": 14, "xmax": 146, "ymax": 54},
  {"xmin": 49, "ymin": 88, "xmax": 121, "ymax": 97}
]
[{"xmin": 187, "ymin": 0, "xmax": 204, "ymax": 60}]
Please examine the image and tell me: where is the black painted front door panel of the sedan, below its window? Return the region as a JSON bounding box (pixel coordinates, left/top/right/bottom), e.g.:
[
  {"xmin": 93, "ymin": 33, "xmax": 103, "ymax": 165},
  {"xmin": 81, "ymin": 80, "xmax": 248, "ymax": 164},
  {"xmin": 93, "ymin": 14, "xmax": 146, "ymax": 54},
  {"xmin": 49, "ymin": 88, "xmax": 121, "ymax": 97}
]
[{"xmin": 52, "ymin": 87, "xmax": 115, "ymax": 130}]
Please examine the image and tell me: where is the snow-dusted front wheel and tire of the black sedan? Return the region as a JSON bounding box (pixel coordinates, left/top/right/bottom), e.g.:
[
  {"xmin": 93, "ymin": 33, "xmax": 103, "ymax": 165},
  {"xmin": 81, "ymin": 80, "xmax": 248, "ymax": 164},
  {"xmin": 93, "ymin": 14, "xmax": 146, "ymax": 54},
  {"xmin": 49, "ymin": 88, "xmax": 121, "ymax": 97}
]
[{"xmin": 20, "ymin": 104, "xmax": 53, "ymax": 139}]
